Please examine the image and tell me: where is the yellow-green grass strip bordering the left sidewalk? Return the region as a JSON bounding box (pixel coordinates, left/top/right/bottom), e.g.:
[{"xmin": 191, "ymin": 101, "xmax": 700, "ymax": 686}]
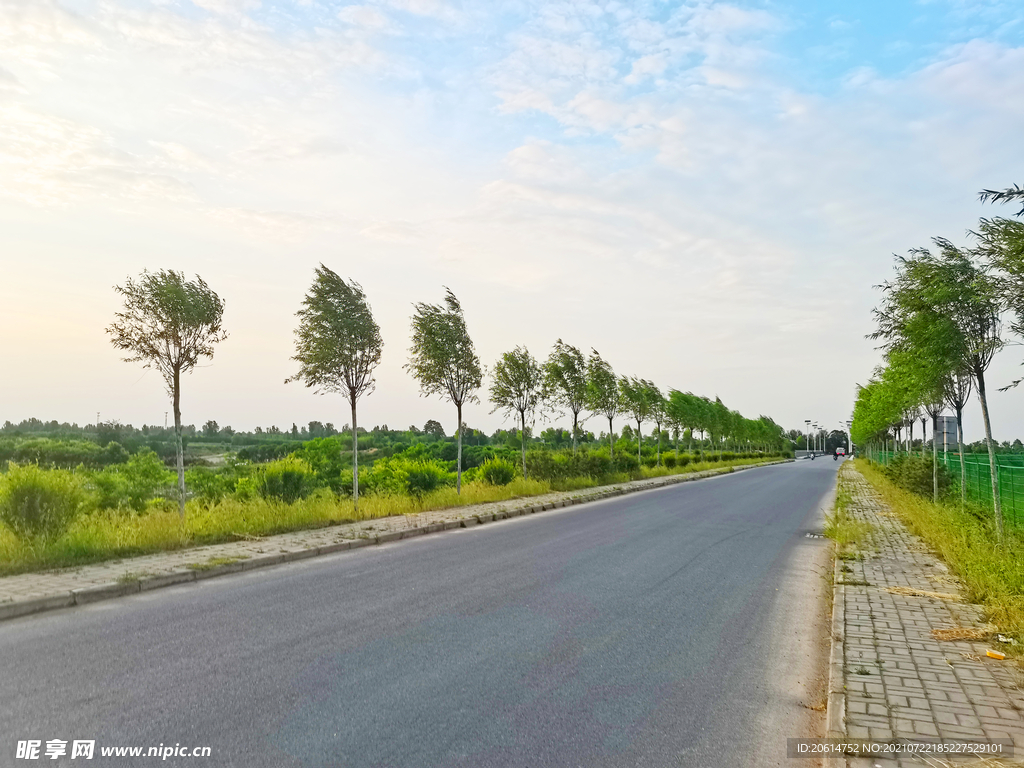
[{"xmin": 0, "ymin": 459, "xmax": 775, "ymax": 575}]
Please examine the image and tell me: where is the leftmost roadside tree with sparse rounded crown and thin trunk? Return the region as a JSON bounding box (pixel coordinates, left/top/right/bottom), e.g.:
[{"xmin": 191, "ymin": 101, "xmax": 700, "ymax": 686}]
[{"xmin": 106, "ymin": 269, "xmax": 227, "ymax": 520}]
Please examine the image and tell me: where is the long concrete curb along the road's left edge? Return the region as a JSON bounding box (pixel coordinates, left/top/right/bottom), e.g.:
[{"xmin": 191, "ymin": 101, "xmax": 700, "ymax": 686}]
[{"xmin": 0, "ymin": 459, "xmax": 794, "ymax": 622}]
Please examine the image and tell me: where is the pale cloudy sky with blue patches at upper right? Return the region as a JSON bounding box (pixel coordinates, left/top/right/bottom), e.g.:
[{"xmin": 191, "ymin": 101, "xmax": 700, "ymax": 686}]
[{"xmin": 0, "ymin": 0, "xmax": 1024, "ymax": 439}]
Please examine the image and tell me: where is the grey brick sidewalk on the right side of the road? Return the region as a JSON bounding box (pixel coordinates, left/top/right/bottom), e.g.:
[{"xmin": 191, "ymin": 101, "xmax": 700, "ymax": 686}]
[{"xmin": 829, "ymin": 463, "xmax": 1024, "ymax": 768}]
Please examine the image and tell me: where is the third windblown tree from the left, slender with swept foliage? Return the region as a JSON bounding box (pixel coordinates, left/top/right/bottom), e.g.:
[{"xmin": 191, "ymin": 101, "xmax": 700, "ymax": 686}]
[{"xmin": 406, "ymin": 288, "xmax": 483, "ymax": 494}]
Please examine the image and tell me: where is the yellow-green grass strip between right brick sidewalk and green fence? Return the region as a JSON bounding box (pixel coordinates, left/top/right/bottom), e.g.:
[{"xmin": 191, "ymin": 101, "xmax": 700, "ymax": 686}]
[{"xmin": 856, "ymin": 459, "xmax": 1024, "ymax": 656}]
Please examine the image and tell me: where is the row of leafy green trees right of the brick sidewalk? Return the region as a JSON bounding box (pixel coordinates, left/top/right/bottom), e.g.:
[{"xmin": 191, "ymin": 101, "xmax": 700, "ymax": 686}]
[{"xmin": 851, "ymin": 186, "xmax": 1024, "ymax": 540}]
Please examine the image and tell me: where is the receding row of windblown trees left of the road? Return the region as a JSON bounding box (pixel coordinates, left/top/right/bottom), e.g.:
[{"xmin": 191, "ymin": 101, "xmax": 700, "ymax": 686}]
[{"xmin": 108, "ymin": 264, "xmax": 785, "ymax": 517}]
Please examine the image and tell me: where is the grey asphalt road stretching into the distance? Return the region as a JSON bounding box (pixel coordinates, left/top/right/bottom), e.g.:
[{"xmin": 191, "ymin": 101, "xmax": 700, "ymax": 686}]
[{"xmin": 0, "ymin": 459, "xmax": 836, "ymax": 768}]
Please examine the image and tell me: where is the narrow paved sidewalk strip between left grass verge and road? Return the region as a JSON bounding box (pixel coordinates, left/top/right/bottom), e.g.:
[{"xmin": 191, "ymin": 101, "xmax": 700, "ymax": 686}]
[{"xmin": 0, "ymin": 462, "xmax": 784, "ymax": 621}]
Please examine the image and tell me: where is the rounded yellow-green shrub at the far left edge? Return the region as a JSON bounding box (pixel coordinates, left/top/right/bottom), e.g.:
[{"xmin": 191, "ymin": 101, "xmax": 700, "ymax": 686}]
[{"xmin": 0, "ymin": 464, "xmax": 87, "ymax": 539}]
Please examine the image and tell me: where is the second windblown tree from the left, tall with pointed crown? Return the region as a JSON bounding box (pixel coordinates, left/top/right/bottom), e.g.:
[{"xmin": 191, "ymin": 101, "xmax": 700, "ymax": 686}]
[{"xmin": 285, "ymin": 264, "xmax": 384, "ymax": 510}]
